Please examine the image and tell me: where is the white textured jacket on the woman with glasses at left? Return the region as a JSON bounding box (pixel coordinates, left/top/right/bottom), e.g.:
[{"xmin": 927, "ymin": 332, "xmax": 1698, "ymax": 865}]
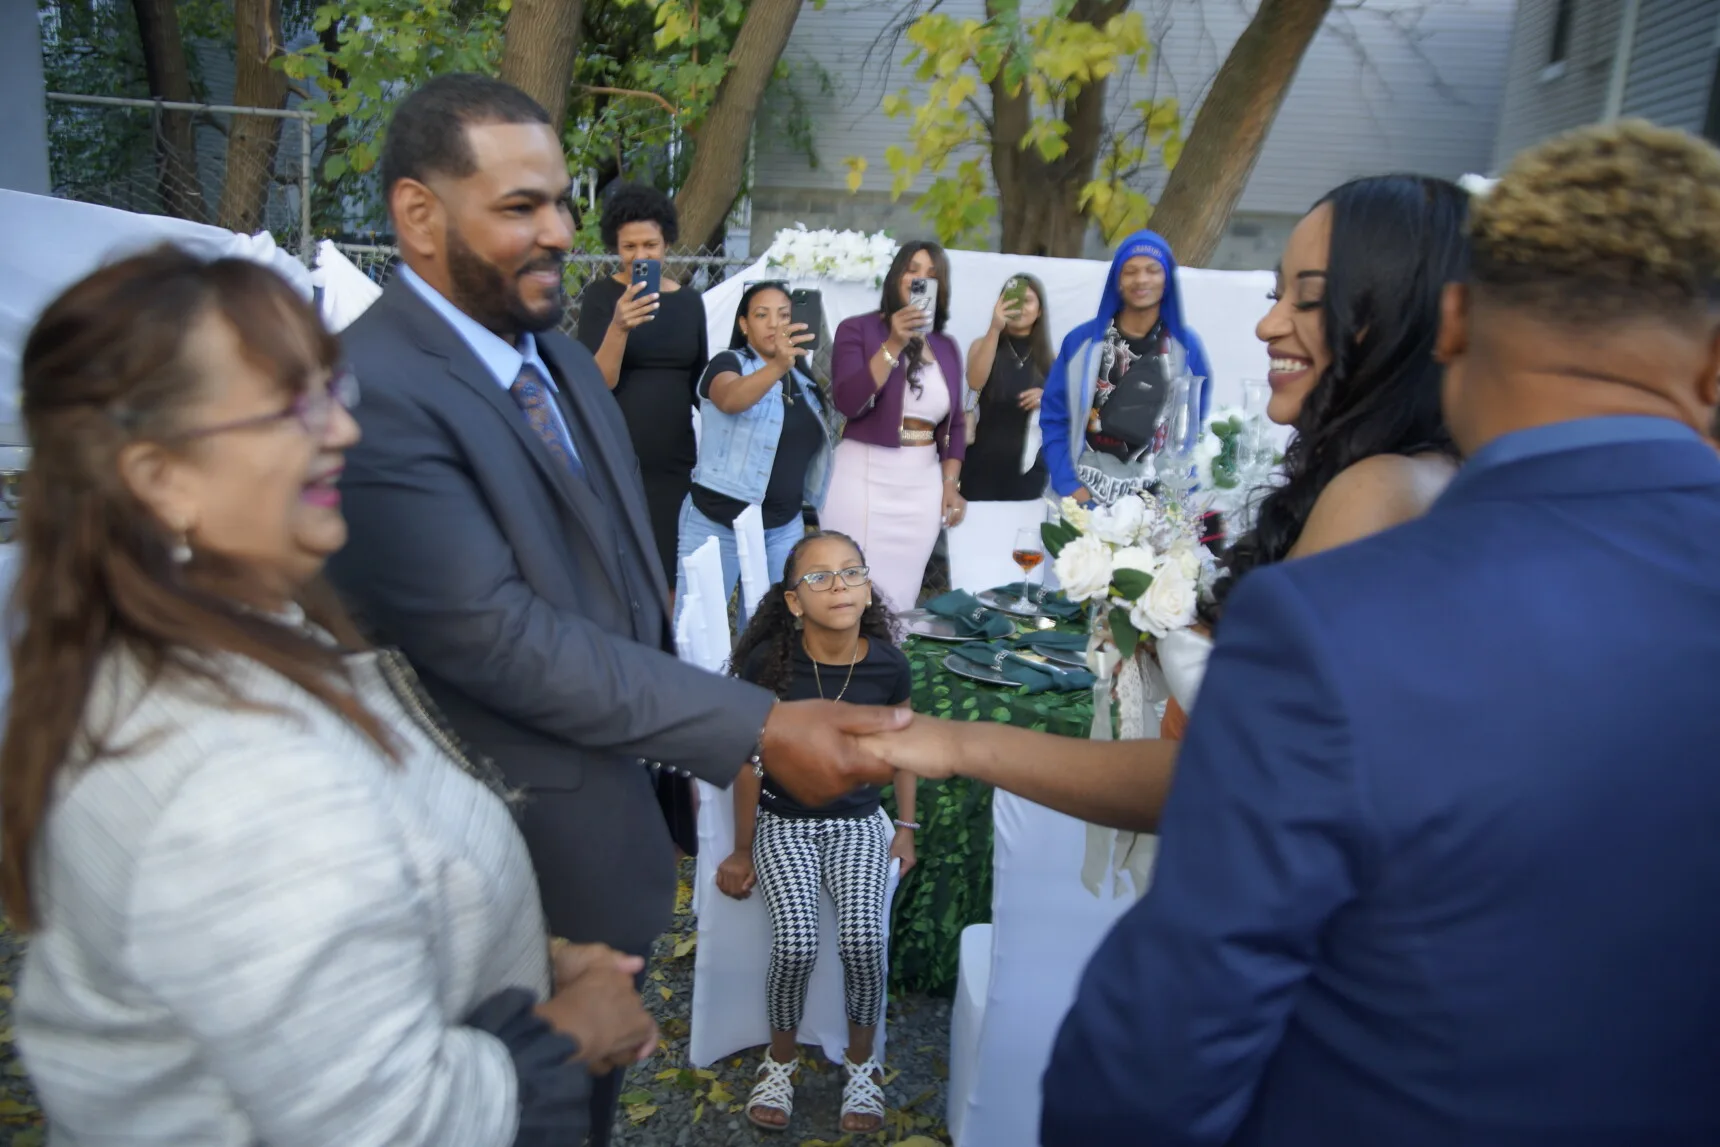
[{"xmin": 15, "ymin": 636, "xmax": 549, "ymax": 1147}]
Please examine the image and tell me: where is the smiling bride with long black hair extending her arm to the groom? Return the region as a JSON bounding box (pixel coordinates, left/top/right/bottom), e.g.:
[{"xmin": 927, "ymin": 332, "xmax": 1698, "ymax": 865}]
[{"xmin": 874, "ymin": 175, "xmax": 1469, "ymax": 832}]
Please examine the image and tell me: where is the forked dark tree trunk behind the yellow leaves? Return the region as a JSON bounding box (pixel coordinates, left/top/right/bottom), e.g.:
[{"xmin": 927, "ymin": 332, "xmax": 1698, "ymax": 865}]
[{"xmin": 986, "ymin": 0, "xmax": 1128, "ymax": 258}]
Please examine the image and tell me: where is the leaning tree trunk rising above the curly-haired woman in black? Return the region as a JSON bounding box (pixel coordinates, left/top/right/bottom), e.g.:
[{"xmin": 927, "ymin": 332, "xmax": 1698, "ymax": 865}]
[{"xmin": 674, "ymin": 0, "xmax": 802, "ymax": 248}]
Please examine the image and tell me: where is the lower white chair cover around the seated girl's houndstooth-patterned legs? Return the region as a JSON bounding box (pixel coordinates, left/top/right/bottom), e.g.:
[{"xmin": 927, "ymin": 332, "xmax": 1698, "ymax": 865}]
[{"xmin": 686, "ymin": 782, "xmax": 900, "ymax": 1068}]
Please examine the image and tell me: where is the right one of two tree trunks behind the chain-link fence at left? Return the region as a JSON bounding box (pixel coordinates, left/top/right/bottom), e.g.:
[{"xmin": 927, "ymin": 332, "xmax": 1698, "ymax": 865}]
[{"xmin": 215, "ymin": 0, "xmax": 288, "ymax": 235}]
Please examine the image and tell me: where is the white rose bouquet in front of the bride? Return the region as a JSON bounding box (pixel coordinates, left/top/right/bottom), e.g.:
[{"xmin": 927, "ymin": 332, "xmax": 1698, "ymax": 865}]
[{"xmin": 1041, "ymin": 490, "xmax": 1218, "ymax": 659}]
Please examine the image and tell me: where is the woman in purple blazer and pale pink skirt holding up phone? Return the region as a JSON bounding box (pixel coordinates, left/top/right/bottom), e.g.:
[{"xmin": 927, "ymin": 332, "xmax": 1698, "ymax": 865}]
[{"xmin": 819, "ymin": 242, "xmax": 967, "ymax": 610}]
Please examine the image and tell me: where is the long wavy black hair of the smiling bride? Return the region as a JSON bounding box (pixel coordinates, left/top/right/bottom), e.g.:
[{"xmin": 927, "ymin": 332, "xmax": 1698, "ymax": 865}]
[{"xmin": 1209, "ymin": 175, "xmax": 1469, "ymax": 619}]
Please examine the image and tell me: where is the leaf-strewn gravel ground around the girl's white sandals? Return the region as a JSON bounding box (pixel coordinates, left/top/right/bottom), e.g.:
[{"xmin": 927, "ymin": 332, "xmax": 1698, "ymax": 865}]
[{"xmin": 0, "ymin": 862, "xmax": 949, "ymax": 1147}]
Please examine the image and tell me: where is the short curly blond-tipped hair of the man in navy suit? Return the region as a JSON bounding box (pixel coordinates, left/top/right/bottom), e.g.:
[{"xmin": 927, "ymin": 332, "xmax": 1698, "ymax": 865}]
[{"xmin": 1469, "ymin": 120, "xmax": 1720, "ymax": 323}]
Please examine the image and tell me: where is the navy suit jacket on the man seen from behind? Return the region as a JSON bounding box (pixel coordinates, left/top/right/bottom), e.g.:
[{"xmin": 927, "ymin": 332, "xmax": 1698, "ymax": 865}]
[{"xmin": 1042, "ymin": 420, "xmax": 1720, "ymax": 1147}]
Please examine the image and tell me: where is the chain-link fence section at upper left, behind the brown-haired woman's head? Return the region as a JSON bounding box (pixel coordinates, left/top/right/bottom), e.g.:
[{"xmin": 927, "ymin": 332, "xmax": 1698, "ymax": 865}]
[{"xmin": 48, "ymin": 91, "xmax": 315, "ymax": 261}]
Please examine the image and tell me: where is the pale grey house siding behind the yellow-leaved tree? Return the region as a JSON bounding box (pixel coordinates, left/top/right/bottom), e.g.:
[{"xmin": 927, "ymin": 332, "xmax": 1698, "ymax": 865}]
[{"xmin": 752, "ymin": 0, "xmax": 1514, "ymax": 268}]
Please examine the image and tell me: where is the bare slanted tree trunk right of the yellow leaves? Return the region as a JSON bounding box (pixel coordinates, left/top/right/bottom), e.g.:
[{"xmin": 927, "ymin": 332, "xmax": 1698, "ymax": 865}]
[{"xmin": 1152, "ymin": 0, "xmax": 1331, "ymax": 267}]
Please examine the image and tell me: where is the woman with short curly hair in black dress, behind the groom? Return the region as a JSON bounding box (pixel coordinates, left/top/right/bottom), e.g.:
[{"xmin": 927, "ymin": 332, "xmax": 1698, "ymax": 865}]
[{"xmin": 580, "ymin": 184, "xmax": 707, "ymax": 585}]
